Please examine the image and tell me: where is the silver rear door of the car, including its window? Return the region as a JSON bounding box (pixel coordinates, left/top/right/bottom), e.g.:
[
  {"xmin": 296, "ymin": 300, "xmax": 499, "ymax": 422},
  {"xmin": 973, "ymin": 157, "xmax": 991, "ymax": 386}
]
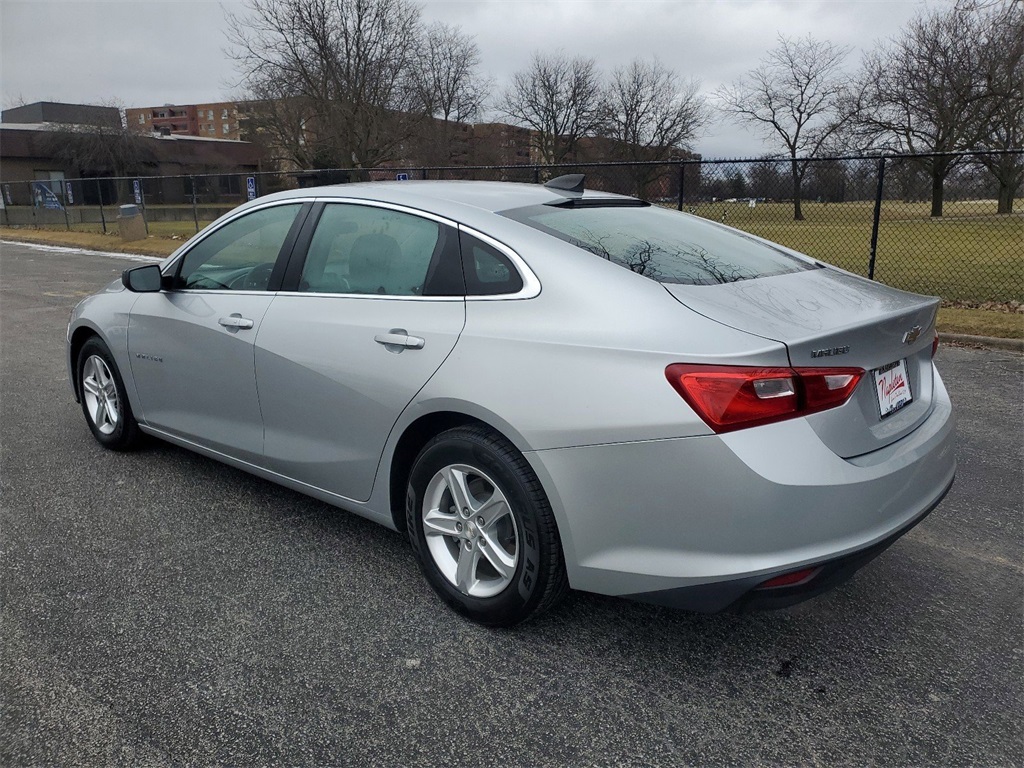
[{"xmin": 256, "ymin": 202, "xmax": 466, "ymax": 501}]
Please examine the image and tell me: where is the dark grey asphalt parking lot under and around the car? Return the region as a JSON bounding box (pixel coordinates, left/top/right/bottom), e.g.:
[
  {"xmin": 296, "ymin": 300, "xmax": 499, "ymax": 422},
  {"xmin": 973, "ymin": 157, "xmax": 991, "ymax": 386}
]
[{"xmin": 0, "ymin": 244, "xmax": 1024, "ymax": 766}]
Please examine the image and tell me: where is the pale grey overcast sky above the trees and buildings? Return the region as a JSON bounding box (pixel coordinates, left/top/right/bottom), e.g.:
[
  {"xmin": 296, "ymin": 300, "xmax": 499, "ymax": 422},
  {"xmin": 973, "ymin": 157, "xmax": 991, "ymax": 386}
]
[{"xmin": 0, "ymin": 0, "xmax": 948, "ymax": 158}]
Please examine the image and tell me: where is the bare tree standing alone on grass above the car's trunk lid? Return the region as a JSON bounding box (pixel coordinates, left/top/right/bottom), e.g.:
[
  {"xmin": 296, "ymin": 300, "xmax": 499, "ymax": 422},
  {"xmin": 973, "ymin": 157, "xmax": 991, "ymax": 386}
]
[{"xmin": 716, "ymin": 35, "xmax": 850, "ymax": 221}]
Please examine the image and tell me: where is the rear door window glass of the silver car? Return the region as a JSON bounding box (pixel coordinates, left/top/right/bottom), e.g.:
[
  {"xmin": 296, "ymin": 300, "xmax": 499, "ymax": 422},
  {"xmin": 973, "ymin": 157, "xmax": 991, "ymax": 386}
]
[{"xmin": 298, "ymin": 203, "xmax": 443, "ymax": 296}]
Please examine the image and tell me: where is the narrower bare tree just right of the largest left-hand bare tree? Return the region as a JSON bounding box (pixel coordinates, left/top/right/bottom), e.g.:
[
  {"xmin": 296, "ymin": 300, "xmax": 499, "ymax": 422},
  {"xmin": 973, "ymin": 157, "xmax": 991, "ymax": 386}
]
[{"xmin": 415, "ymin": 23, "xmax": 493, "ymax": 164}]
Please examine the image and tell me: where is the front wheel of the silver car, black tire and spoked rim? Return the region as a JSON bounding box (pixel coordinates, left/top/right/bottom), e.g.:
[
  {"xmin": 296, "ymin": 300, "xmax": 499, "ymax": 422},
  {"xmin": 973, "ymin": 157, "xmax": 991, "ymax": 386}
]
[{"xmin": 77, "ymin": 336, "xmax": 140, "ymax": 451}]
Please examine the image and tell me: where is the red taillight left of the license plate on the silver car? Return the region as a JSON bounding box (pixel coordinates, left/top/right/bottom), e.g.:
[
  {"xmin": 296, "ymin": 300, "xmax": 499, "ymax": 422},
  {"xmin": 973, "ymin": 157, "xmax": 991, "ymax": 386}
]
[{"xmin": 665, "ymin": 362, "xmax": 864, "ymax": 433}]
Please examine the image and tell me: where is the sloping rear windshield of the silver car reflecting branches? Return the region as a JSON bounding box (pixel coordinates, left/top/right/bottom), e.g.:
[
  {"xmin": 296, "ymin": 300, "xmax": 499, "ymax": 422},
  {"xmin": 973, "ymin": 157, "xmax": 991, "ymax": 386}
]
[{"xmin": 502, "ymin": 201, "xmax": 815, "ymax": 286}]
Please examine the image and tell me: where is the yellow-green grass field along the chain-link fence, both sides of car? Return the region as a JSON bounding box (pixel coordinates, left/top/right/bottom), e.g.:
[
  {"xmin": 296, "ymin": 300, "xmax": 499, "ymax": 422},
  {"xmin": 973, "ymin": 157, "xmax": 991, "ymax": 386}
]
[{"xmin": 0, "ymin": 201, "xmax": 1024, "ymax": 338}]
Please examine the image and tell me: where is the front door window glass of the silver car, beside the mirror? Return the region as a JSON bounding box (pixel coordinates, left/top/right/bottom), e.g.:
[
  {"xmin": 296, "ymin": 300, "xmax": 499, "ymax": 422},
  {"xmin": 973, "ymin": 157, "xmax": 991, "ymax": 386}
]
[{"xmin": 175, "ymin": 203, "xmax": 302, "ymax": 291}]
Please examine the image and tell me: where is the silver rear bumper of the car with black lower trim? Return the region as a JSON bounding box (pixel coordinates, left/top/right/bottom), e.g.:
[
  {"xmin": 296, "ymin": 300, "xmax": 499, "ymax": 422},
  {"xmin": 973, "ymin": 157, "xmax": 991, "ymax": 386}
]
[{"xmin": 527, "ymin": 366, "xmax": 956, "ymax": 611}]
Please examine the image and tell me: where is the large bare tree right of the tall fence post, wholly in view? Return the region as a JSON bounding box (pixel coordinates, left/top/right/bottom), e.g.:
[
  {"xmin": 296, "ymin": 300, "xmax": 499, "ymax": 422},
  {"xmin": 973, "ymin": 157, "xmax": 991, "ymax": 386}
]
[{"xmin": 851, "ymin": 0, "xmax": 1007, "ymax": 216}]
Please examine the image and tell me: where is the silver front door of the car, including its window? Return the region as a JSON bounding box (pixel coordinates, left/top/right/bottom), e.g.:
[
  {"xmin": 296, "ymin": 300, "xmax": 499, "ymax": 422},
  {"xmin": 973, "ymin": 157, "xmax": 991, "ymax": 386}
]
[{"xmin": 128, "ymin": 203, "xmax": 303, "ymax": 463}]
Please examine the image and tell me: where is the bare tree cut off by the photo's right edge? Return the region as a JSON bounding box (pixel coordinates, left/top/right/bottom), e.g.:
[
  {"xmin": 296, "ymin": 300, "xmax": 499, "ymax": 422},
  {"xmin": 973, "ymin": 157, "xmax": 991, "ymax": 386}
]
[{"xmin": 978, "ymin": 2, "xmax": 1024, "ymax": 214}]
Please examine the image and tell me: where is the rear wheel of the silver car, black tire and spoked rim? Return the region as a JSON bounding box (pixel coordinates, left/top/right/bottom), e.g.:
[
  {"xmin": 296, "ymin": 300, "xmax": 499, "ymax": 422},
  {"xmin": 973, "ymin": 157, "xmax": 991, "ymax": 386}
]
[{"xmin": 406, "ymin": 426, "xmax": 568, "ymax": 627}]
